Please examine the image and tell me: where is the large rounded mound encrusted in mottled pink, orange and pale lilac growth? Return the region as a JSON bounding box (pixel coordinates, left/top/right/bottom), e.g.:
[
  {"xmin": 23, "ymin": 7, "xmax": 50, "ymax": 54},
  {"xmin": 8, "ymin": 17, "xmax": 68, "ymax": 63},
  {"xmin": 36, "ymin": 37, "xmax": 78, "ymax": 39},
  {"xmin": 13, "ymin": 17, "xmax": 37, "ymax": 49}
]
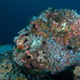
[{"xmin": 0, "ymin": 8, "xmax": 80, "ymax": 80}]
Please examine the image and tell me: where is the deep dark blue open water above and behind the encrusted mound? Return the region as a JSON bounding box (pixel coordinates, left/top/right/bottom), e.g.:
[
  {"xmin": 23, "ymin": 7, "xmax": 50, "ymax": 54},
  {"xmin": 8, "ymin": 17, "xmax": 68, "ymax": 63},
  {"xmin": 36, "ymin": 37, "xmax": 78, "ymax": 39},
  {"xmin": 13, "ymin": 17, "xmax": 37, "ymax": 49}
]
[{"xmin": 0, "ymin": 0, "xmax": 80, "ymax": 44}]
